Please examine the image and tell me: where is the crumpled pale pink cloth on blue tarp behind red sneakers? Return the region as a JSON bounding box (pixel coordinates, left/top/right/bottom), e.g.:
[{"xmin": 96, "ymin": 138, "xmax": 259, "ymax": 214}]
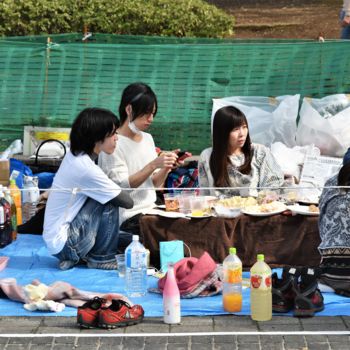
[{"xmin": 0, "ymin": 278, "xmax": 133, "ymax": 307}]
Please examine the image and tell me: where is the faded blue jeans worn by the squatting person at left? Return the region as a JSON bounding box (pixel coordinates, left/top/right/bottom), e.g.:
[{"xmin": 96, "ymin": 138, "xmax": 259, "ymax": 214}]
[{"xmin": 55, "ymin": 198, "xmax": 132, "ymax": 269}]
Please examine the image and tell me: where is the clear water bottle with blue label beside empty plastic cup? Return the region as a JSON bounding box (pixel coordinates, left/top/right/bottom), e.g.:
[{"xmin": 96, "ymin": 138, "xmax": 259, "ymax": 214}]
[{"xmin": 125, "ymin": 235, "xmax": 147, "ymax": 297}]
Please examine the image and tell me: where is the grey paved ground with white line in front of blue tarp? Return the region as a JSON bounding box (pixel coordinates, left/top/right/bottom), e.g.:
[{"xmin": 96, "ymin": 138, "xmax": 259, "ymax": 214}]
[{"xmin": 0, "ymin": 316, "xmax": 350, "ymax": 350}]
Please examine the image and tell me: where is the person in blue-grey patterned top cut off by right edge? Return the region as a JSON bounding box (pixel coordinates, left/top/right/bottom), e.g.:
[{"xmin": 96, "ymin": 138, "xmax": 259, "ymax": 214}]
[{"xmin": 318, "ymin": 148, "xmax": 350, "ymax": 297}]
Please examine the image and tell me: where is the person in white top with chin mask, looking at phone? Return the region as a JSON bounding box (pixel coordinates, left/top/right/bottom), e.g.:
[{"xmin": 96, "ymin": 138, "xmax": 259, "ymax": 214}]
[{"xmin": 98, "ymin": 83, "xmax": 178, "ymax": 234}]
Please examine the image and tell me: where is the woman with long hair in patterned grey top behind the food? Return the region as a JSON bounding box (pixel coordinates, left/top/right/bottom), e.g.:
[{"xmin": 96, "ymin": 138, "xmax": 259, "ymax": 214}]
[{"xmin": 198, "ymin": 106, "xmax": 284, "ymax": 196}]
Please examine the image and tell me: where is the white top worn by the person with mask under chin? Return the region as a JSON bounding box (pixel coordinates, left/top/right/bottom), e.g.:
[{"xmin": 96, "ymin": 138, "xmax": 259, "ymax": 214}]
[{"xmin": 98, "ymin": 132, "xmax": 157, "ymax": 224}]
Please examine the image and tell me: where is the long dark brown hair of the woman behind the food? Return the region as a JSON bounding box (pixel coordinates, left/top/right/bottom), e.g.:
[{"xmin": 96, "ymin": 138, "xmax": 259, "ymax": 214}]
[{"xmin": 209, "ymin": 106, "xmax": 252, "ymax": 187}]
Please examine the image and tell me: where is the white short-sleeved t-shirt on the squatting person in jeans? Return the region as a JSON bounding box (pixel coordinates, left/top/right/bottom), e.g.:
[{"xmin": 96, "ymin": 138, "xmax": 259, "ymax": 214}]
[{"xmin": 43, "ymin": 152, "xmax": 121, "ymax": 254}]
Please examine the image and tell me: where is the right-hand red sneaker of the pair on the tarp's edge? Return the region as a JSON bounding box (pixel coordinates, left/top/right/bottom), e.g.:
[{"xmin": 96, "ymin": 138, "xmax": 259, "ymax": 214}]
[{"xmin": 98, "ymin": 299, "xmax": 144, "ymax": 328}]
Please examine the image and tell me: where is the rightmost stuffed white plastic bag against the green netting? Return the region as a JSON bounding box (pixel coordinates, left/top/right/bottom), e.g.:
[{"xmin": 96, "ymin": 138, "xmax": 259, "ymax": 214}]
[{"xmin": 296, "ymin": 94, "xmax": 350, "ymax": 157}]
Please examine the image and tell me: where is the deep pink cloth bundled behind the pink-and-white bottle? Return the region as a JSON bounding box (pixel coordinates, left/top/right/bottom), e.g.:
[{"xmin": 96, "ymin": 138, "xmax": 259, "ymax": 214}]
[{"xmin": 158, "ymin": 252, "xmax": 217, "ymax": 296}]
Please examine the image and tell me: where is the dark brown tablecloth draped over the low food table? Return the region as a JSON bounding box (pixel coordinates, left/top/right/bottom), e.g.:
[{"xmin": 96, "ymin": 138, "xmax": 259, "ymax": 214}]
[{"xmin": 140, "ymin": 215, "xmax": 320, "ymax": 267}]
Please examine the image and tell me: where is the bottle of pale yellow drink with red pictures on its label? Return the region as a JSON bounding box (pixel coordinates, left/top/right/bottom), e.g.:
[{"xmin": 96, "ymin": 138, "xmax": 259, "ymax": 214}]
[{"xmin": 250, "ymin": 254, "xmax": 272, "ymax": 321}]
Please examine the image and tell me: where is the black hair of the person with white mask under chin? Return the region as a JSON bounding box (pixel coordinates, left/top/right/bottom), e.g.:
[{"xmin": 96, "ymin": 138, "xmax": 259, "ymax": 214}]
[{"xmin": 119, "ymin": 83, "xmax": 158, "ymax": 125}]
